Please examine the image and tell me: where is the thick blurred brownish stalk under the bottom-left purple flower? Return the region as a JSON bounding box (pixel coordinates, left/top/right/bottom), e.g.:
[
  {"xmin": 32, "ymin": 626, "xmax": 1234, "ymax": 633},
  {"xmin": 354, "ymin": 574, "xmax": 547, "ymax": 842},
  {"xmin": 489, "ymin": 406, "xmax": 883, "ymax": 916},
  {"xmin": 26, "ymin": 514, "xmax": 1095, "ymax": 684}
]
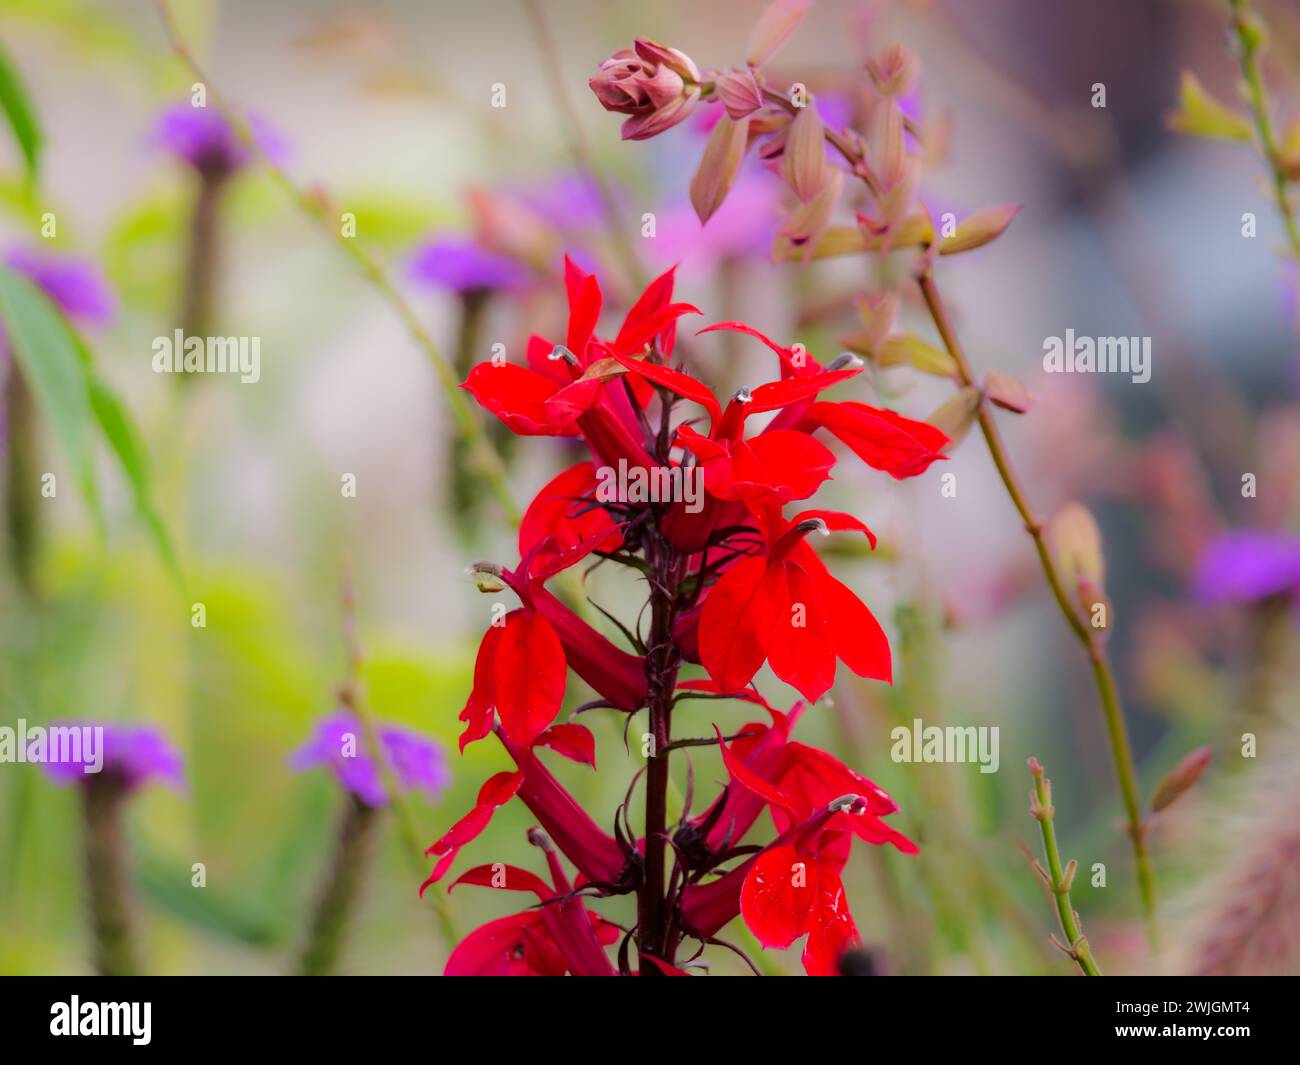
[{"xmin": 81, "ymin": 771, "xmax": 139, "ymax": 977}]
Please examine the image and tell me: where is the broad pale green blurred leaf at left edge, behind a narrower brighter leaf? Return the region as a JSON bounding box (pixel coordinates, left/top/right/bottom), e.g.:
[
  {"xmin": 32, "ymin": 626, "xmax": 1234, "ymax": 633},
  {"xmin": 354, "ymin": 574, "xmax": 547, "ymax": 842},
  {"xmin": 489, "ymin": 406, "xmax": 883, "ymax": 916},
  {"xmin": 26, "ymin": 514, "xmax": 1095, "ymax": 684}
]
[{"xmin": 0, "ymin": 267, "xmax": 100, "ymax": 521}]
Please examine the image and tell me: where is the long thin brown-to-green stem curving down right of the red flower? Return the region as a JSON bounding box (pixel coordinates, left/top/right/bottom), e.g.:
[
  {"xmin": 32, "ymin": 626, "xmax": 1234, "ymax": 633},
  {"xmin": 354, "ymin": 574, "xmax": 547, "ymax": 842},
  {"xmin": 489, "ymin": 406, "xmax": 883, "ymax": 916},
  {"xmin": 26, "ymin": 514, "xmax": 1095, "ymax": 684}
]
[{"xmin": 917, "ymin": 269, "xmax": 1160, "ymax": 949}]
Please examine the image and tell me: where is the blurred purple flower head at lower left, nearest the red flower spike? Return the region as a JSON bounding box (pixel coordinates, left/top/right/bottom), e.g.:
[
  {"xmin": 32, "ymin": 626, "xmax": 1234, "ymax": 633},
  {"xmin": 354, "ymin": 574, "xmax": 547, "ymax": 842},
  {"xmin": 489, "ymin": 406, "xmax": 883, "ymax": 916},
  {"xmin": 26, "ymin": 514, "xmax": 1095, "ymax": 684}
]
[{"xmin": 289, "ymin": 710, "xmax": 451, "ymax": 806}]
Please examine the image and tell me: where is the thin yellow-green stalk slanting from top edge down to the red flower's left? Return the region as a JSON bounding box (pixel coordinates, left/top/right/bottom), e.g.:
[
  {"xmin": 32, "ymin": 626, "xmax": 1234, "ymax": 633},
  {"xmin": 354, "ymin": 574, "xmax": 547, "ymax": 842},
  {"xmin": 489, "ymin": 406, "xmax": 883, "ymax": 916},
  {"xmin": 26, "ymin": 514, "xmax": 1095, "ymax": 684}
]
[{"xmin": 155, "ymin": 0, "xmax": 521, "ymax": 525}]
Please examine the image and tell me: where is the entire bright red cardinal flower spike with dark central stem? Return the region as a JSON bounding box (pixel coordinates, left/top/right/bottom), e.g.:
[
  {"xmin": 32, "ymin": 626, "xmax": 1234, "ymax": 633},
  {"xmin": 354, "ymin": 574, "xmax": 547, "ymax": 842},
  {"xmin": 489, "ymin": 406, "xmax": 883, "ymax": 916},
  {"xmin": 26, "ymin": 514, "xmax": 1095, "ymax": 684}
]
[{"xmin": 439, "ymin": 253, "xmax": 946, "ymax": 975}]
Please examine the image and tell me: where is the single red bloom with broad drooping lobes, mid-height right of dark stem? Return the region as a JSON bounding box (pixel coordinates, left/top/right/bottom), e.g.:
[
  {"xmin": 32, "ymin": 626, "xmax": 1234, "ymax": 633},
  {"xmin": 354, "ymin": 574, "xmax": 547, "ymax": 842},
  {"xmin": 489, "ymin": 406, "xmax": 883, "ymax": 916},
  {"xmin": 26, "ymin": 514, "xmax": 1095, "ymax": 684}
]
[{"xmin": 698, "ymin": 508, "xmax": 892, "ymax": 700}]
